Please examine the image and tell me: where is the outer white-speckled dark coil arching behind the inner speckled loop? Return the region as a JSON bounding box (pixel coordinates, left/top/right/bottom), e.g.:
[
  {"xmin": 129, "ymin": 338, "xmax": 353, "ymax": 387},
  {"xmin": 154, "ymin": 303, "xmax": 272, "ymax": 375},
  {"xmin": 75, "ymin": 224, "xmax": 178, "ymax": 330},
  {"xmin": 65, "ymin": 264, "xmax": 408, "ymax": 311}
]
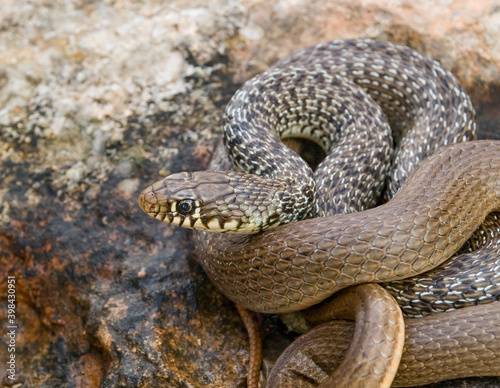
[{"xmin": 276, "ymin": 39, "xmax": 476, "ymax": 198}]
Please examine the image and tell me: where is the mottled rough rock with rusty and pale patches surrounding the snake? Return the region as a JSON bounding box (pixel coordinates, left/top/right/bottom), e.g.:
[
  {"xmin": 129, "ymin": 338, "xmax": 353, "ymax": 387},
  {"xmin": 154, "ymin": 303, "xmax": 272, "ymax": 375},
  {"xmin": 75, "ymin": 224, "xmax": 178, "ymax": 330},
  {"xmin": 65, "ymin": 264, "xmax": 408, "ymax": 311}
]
[{"xmin": 0, "ymin": 0, "xmax": 500, "ymax": 387}]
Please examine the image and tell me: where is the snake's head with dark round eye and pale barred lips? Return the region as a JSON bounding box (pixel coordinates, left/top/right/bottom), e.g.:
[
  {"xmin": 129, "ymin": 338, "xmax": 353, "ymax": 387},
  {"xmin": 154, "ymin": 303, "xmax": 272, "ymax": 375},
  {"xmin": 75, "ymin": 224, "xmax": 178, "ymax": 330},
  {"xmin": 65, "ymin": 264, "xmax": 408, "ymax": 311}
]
[{"xmin": 138, "ymin": 171, "xmax": 292, "ymax": 234}]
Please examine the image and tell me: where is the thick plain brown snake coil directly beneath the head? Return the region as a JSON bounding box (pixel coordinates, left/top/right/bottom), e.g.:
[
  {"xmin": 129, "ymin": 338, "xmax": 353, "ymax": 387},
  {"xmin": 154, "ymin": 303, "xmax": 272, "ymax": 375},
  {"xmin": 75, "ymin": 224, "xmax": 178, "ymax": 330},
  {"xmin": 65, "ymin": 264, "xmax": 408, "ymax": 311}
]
[{"xmin": 188, "ymin": 141, "xmax": 500, "ymax": 313}]
